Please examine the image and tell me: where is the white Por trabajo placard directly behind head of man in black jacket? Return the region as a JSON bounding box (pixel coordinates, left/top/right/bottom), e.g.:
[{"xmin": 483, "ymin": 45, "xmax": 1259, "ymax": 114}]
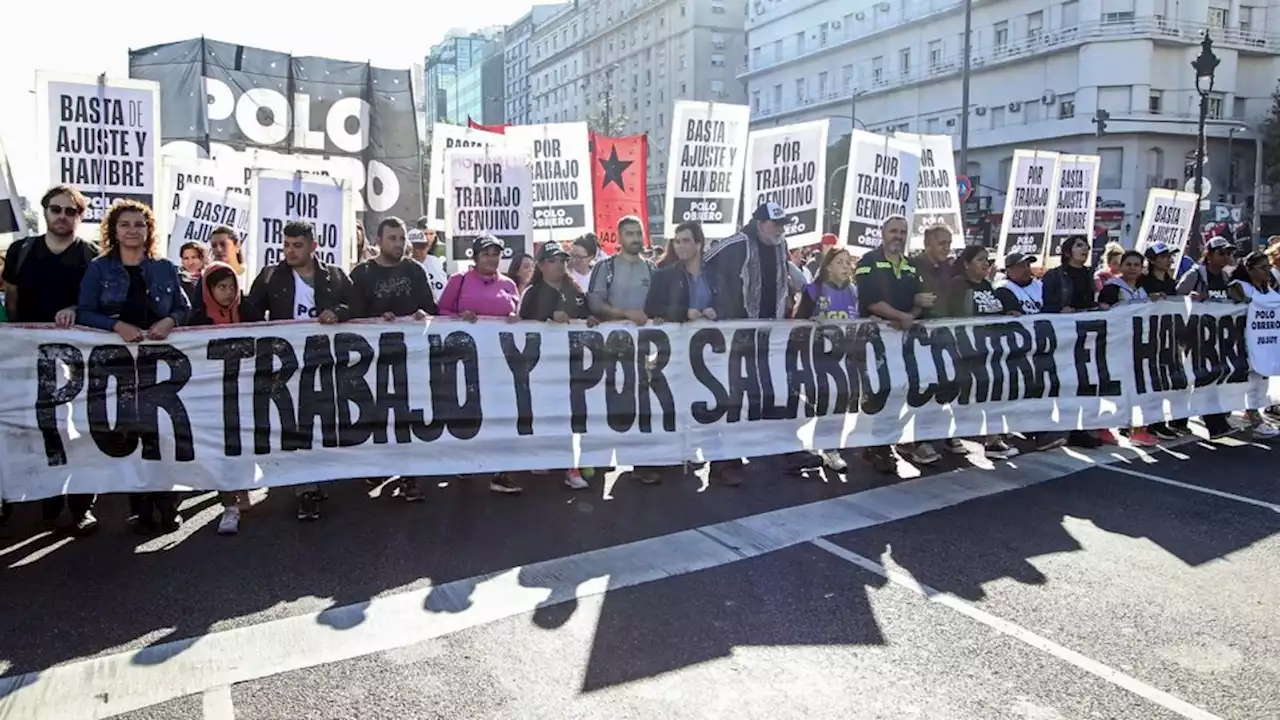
[{"xmin": 244, "ymin": 170, "xmax": 356, "ymax": 277}]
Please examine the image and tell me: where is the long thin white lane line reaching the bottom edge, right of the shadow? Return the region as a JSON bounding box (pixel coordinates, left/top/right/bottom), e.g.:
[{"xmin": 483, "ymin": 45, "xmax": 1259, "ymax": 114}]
[{"xmin": 810, "ymin": 538, "xmax": 1222, "ymax": 720}]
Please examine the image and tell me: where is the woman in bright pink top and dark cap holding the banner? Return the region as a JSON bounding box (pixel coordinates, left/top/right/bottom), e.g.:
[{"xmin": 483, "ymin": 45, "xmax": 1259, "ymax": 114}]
[{"xmin": 438, "ymin": 234, "xmax": 522, "ymax": 495}]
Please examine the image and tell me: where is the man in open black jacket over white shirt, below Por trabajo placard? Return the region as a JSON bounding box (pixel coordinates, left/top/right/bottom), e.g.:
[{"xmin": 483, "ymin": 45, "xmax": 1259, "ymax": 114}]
[{"xmin": 242, "ymin": 220, "xmax": 352, "ymax": 520}]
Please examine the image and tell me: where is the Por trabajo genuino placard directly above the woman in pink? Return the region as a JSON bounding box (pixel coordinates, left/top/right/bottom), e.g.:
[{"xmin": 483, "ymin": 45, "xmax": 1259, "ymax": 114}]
[{"xmin": 444, "ymin": 147, "xmax": 534, "ymax": 261}]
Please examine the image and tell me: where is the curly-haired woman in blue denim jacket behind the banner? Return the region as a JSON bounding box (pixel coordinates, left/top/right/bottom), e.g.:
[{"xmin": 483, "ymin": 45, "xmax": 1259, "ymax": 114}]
[{"xmin": 76, "ymin": 200, "xmax": 191, "ymax": 533}]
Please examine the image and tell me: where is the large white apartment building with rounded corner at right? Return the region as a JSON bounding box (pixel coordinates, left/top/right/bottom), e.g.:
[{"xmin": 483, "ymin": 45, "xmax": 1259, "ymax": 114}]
[{"xmin": 740, "ymin": 0, "xmax": 1280, "ymax": 243}]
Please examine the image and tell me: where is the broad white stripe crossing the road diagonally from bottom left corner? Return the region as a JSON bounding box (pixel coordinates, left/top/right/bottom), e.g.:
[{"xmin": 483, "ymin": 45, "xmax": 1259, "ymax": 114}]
[{"xmin": 0, "ymin": 440, "xmax": 1172, "ymax": 720}]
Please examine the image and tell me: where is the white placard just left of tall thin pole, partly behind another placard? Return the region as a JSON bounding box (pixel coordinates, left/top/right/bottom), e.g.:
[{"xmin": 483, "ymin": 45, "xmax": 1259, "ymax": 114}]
[{"xmin": 893, "ymin": 132, "xmax": 965, "ymax": 251}]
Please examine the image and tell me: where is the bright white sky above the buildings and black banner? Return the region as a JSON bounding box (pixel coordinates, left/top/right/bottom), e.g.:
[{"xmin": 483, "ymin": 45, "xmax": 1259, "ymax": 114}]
[{"xmin": 0, "ymin": 0, "xmax": 532, "ymax": 200}]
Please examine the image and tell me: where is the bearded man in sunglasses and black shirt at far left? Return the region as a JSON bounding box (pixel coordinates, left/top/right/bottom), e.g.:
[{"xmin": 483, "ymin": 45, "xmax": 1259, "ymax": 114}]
[{"xmin": 4, "ymin": 184, "xmax": 99, "ymax": 536}]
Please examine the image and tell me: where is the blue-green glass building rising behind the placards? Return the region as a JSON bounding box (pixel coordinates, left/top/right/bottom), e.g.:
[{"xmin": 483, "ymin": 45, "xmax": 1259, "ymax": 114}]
[{"xmin": 424, "ymin": 33, "xmax": 504, "ymax": 128}]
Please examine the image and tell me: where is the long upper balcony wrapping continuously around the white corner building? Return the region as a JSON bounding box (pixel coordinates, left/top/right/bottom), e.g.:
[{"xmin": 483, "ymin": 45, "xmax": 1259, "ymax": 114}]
[{"xmin": 751, "ymin": 15, "xmax": 1280, "ymax": 122}]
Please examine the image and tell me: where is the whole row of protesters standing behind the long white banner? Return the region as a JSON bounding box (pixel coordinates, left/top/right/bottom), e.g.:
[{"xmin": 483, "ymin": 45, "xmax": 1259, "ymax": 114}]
[{"xmin": 4, "ymin": 186, "xmax": 1280, "ymax": 534}]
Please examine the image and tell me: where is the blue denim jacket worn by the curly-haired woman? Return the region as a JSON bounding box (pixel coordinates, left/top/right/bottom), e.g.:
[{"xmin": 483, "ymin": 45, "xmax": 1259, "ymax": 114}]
[{"xmin": 76, "ymin": 254, "xmax": 191, "ymax": 332}]
